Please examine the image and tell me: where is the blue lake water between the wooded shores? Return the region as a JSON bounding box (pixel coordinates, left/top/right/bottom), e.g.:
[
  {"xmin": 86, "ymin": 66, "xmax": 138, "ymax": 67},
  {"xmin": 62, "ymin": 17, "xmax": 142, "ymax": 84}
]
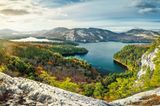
[{"xmin": 77, "ymin": 42, "xmax": 132, "ymax": 73}]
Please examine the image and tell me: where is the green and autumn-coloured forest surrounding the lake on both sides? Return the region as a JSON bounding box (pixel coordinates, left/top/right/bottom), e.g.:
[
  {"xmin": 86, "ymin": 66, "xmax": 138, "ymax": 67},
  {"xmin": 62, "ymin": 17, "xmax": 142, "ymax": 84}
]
[{"xmin": 0, "ymin": 40, "xmax": 160, "ymax": 101}]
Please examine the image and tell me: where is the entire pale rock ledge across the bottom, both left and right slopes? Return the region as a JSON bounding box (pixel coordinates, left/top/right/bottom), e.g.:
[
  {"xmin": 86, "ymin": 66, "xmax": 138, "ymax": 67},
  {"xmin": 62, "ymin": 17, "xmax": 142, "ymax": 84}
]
[{"xmin": 0, "ymin": 72, "xmax": 160, "ymax": 106}]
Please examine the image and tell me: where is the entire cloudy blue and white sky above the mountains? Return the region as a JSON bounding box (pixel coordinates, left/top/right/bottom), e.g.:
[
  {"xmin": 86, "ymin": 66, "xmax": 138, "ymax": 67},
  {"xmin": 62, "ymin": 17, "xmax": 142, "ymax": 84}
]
[{"xmin": 0, "ymin": 0, "xmax": 160, "ymax": 31}]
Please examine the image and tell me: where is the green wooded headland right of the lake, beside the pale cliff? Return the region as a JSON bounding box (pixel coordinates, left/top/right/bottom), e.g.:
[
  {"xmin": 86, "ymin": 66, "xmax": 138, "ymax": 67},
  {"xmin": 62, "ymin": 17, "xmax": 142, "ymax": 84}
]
[{"xmin": 114, "ymin": 44, "xmax": 149, "ymax": 70}]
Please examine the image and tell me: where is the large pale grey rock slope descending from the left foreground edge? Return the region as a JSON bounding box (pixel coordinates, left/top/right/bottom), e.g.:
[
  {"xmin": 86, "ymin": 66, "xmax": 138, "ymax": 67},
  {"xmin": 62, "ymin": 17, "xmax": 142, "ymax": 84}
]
[{"xmin": 0, "ymin": 73, "xmax": 108, "ymax": 106}]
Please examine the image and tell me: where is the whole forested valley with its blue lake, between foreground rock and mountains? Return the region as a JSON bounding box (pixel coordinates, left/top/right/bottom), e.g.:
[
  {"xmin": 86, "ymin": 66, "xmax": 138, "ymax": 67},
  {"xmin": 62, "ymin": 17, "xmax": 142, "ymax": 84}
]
[{"xmin": 0, "ymin": 28, "xmax": 160, "ymax": 105}]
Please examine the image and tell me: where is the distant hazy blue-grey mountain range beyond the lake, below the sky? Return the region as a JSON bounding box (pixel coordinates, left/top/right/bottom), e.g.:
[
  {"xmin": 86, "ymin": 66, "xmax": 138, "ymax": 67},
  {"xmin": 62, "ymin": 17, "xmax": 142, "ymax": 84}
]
[{"xmin": 0, "ymin": 27, "xmax": 160, "ymax": 43}]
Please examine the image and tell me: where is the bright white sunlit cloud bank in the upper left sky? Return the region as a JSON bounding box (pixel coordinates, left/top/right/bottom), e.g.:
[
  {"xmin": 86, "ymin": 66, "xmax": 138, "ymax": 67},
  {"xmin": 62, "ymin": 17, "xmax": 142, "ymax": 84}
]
[{"xmin": 0, "ymin": 0, "xmax": 73, "ymax": 30}]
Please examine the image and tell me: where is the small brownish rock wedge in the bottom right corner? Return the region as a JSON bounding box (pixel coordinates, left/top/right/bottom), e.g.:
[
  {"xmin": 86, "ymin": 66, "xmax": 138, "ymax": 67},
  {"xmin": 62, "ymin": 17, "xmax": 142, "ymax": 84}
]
[{"xmin": 110, "ymin": 88, "xmax": 160, "ymax": 106}]
